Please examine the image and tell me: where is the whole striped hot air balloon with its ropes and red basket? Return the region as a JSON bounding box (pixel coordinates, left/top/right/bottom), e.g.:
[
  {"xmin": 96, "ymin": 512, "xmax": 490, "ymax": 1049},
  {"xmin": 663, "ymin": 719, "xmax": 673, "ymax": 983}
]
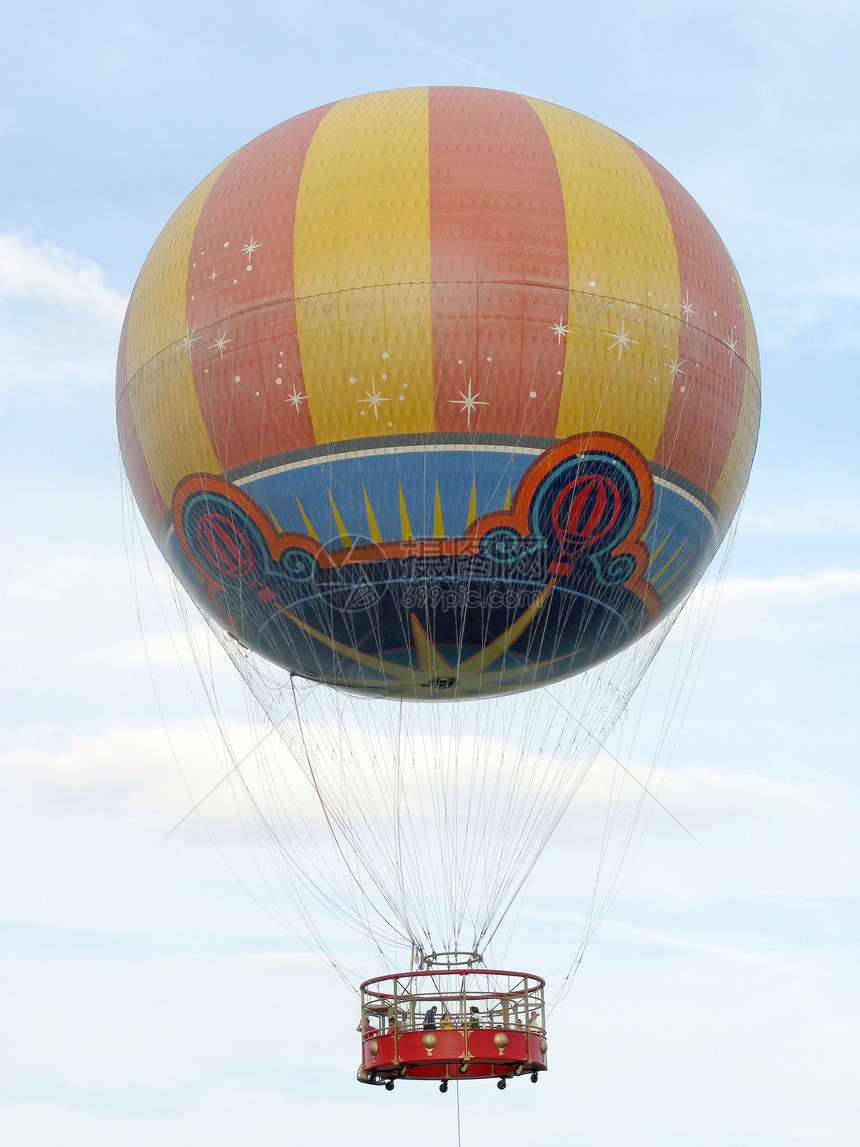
[{"xmin": 117, "ymin": 87, "xmax": 760, "ymax": 1084}]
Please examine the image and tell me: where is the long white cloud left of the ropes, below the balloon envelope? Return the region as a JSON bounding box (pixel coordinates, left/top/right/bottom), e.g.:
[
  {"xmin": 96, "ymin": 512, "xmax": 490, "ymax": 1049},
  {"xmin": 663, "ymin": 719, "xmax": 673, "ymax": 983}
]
[{"xmin": 0, "ymin": 720, "xmax": 396, "ymax": 949}]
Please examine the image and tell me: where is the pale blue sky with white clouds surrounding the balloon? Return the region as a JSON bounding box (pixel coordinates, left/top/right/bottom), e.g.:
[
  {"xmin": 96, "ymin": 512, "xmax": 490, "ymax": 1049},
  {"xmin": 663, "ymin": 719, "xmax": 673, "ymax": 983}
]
[{"xmin": 0, "ymin": 0, "xmax": 860, "ymax": 1147}]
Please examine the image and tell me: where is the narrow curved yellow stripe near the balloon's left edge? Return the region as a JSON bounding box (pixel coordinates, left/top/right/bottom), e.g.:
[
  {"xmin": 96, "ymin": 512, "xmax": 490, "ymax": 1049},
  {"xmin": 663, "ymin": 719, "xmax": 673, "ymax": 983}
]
[{"xmin": 126, "ymin": 159, "xmax": 229, "ymax": 506}]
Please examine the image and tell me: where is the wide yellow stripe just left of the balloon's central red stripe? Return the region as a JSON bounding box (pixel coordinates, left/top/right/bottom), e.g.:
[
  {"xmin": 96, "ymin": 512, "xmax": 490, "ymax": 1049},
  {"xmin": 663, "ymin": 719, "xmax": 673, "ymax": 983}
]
[{"xmin": 294, "ymin": 88, "xmax": 435, "ymax": 443}]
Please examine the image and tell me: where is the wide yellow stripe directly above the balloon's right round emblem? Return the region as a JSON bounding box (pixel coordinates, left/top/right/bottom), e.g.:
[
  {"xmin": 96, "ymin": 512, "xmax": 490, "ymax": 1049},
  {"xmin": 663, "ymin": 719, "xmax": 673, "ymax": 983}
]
[{"xmin": 527, "ymin": 97, "xmax": 680, "ymax": 458}]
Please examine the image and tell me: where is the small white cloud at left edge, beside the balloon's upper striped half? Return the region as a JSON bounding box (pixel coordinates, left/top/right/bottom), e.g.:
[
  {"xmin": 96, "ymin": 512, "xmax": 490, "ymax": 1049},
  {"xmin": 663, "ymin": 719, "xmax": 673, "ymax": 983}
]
[{"xmin": 0, "ymin": 231, "xmax": 127, "ymax": 325}]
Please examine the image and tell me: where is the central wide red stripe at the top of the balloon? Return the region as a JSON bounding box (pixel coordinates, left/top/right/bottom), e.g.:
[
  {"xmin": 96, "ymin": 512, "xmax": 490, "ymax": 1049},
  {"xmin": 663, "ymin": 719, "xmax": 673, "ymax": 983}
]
[{"xmin": 430, "ymin": 87, "xmax": 568, "ymax": 437}]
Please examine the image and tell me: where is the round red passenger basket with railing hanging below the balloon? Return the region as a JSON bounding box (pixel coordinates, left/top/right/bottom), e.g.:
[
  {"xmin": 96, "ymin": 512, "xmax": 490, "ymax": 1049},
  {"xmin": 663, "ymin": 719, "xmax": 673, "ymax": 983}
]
[{"xmin": 358, "ymin": 968, "xmax": 547, "ymax": 1091}]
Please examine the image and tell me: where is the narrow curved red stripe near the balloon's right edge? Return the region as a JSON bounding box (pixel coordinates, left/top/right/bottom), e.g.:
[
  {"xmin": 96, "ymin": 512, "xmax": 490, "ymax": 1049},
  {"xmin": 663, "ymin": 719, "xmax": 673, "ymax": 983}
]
[{"xmin": 631, "ymin": 145, "xmax": 746, "ymax": 493}]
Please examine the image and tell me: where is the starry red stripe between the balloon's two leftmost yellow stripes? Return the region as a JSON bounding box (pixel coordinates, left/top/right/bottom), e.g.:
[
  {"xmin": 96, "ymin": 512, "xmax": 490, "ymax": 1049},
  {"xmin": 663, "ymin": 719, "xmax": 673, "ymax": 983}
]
[{"xmin": 186, "ymin": 107, "xmax": 328, "ymax": 470}]
